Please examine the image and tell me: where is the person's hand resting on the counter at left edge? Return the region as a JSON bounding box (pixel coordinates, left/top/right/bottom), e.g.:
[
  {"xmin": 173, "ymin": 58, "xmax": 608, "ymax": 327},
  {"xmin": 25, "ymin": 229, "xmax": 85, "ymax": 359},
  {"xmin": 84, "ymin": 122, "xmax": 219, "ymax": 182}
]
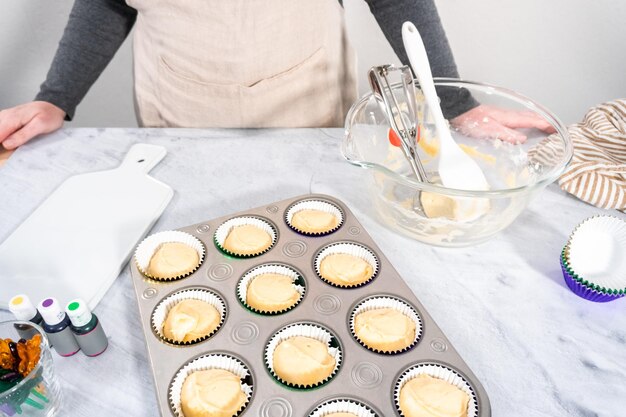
[{"xmin": 0, "ymin": 101, "xmax": 65, "ymax": 150}]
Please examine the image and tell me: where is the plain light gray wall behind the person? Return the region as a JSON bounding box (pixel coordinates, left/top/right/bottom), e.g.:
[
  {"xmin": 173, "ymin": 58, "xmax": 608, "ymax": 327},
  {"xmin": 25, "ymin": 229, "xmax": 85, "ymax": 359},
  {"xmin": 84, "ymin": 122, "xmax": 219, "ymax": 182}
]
[{"xmin": 0, "ymin": 0, "xmax": 626, "ymax": 127}]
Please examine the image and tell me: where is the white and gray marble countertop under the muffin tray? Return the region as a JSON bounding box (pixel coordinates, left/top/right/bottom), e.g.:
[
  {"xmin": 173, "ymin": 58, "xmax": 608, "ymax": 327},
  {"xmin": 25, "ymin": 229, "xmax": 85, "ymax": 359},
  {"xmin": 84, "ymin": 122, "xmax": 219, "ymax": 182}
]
[{"xmin": 0, "ymin": 129, "xmax": 626, "ymax": 417}]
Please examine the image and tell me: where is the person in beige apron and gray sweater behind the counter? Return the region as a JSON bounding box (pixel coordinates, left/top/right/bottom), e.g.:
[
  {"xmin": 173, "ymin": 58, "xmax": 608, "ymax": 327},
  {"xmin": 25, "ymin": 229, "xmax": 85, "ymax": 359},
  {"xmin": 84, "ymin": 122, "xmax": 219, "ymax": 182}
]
[{"xmin": 0, "ymin": 0, "xmax": 545, "ymax": 149}]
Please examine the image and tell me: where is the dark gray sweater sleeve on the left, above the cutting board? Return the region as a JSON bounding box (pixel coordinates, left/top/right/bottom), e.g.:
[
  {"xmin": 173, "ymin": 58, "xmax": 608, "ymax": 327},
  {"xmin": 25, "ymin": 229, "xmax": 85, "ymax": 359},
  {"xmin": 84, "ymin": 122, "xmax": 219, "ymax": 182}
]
[{"xmin": 35, "ymin": 0, "xmax": 137, "ymax": 120}]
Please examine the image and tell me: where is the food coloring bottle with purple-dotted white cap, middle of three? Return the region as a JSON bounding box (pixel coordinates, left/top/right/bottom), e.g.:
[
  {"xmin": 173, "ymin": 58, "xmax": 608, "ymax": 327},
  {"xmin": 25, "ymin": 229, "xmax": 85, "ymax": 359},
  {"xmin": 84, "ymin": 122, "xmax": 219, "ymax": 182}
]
[{"xmin": 38, "ymin": 298, "xmax": 80, "ymax": 356}]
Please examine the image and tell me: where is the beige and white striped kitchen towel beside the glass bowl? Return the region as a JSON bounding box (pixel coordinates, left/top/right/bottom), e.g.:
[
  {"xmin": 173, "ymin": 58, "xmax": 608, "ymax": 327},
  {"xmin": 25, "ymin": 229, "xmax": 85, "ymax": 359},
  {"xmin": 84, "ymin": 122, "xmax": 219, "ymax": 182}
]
[{"xmin": 529, "ymin": 99, "xmax": 626, "ymax": 212}]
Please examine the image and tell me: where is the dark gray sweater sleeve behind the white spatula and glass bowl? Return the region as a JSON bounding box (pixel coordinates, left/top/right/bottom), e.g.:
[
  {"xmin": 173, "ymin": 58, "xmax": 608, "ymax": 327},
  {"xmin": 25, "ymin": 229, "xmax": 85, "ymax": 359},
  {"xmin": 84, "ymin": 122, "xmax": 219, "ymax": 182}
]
[{"xmin": 365, "ymin": 0, "xmax": 478, "ymax": 119}]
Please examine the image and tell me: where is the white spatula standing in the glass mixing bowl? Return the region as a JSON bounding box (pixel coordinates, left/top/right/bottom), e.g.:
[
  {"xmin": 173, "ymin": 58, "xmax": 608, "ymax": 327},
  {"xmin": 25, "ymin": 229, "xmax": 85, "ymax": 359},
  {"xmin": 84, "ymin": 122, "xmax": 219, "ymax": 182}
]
[{"xmin": 402, "ymin": 22, "xmax": 489, "ymax": 190}]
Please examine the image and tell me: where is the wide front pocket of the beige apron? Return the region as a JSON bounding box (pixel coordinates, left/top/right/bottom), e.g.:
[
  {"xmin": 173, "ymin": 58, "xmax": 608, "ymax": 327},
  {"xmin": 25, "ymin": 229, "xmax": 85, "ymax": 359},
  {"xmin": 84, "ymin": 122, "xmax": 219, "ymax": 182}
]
[{"xmin": 157, "ymin": 47, "xmax": 336, "ymax": 128}]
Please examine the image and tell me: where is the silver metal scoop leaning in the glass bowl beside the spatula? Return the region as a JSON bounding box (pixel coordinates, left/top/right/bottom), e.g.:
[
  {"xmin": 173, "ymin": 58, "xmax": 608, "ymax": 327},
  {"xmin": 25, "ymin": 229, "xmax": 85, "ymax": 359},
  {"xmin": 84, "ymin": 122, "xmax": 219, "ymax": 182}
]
[{"xmin": 369, "ymin": 65, "xmax": 429, "ymax": 182}]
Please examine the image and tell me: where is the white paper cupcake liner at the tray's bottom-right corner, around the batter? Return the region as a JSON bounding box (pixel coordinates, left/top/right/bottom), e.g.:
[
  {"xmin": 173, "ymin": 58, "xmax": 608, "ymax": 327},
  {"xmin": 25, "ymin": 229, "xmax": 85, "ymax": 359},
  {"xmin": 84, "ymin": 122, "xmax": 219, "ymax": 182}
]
[{"xmin": 393, "ymin": 362, "xmax": 479, "ymax": 417}]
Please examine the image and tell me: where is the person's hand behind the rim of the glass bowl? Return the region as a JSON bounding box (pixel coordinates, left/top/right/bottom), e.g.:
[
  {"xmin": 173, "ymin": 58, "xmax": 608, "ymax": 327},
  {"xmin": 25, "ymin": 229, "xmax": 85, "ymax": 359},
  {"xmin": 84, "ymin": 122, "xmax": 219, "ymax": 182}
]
[{"xmin": 450, "ymin": 104, "xmax": 555, "ymax": 144}]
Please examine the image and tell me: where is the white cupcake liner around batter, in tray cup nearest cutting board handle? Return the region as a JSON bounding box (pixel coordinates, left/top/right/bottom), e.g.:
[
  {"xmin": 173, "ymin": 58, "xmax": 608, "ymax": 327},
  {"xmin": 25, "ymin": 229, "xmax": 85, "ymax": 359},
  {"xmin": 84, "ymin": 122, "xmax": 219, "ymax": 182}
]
[{"xmin": 134, "ymin": 230, "xmax": 205, "ymax": 281}]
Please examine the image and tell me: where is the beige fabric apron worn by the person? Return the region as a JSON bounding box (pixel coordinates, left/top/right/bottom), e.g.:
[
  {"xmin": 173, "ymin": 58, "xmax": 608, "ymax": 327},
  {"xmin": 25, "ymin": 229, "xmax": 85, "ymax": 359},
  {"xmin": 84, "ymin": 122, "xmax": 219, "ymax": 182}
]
[{"xmin": 127, "ymin": 0, "xmax": 356, "ymax": 127}]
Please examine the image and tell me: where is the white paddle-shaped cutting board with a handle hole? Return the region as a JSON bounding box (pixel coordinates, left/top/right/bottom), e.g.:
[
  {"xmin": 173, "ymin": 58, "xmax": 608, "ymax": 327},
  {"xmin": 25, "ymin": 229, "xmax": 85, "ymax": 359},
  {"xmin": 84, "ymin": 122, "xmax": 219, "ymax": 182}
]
[{"xmin": 0, "ymin": 144, "xmax": 174, "ymax": 309}]
